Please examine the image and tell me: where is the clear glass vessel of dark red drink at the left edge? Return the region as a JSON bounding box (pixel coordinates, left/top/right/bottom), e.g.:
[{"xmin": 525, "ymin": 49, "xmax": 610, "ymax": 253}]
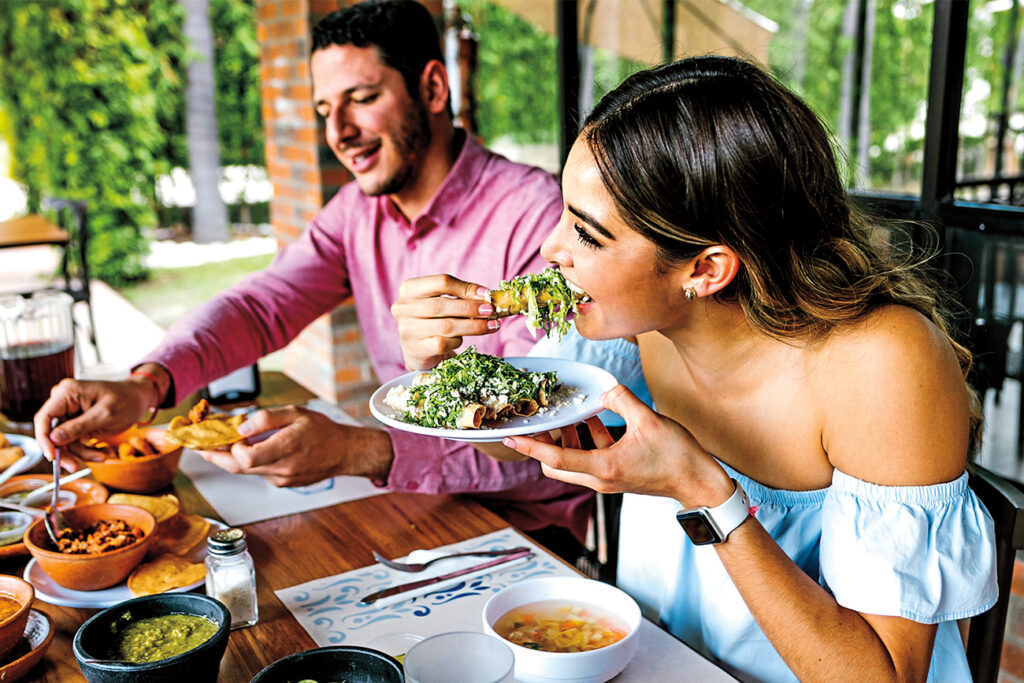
[{"xmin": 0, "ymin": 290, "xmax": 75, "ymax": 424}]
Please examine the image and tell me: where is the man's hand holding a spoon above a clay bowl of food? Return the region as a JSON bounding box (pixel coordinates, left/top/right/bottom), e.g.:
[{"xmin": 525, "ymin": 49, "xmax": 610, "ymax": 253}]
[{"xmin": 34, "ymin": 377, "xmax": 163, "ymax": 467}]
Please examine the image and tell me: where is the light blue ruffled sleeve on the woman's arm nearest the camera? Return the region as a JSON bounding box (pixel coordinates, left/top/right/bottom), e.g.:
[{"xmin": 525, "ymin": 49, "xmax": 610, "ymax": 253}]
[{"xmin": 820, "ymin": 470, "xmax": 998, "ymax": 624}]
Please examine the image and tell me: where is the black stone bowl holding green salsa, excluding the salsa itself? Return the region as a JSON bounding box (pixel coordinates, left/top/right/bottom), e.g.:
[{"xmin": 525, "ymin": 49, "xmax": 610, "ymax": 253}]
[{"xmin": 72, "ymin": 593, "xmax": 231, "ymax": 683}]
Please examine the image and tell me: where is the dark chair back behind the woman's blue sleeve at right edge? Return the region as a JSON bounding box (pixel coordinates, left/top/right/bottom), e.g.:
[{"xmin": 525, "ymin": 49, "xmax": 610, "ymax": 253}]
[{"xmin": 967, "ymin": 463, "xmax": 1024, "ymax": 683}]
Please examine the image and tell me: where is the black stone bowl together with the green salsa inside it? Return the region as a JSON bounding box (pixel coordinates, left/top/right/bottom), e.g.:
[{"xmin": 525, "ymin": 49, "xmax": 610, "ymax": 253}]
[{"xmin": 72, "ymin": 593, "xmax": 231, "ymax": 683}]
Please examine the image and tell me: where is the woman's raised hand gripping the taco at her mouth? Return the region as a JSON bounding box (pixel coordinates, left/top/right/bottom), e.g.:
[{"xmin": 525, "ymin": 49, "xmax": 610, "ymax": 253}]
[{"xmin": 391, "ymin": 275, "xmax": 501, "ymax": 370}]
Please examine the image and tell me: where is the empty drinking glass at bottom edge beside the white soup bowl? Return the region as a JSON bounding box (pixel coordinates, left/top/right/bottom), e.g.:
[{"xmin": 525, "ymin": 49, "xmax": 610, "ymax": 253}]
[{"xmin": 404, "ymin": 631, "xmax": 515, "ymax": 683}]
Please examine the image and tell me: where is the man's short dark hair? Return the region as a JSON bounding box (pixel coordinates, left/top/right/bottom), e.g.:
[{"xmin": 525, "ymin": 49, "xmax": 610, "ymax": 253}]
[{"xmin": 312, "ymin": 0, "xmax": 442, "ymax": 99}]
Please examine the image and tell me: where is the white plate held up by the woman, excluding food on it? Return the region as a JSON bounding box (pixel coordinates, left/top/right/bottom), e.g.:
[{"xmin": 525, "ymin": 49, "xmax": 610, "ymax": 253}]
[{"xmin": 370, "ymin": 356, "xmax": 618, "ymax": 442}]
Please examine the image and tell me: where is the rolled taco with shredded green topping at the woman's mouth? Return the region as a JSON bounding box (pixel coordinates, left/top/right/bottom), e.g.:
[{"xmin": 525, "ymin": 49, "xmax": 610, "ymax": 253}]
[{"xmin": 487, "ymin": 268, "xmax": 590, "ymax": 339}]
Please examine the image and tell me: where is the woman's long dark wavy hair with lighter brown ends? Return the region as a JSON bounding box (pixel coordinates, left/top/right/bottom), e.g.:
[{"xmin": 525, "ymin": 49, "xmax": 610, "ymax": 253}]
[{"xmin": 581, "ymin": 56, "xmax": 981, "ymax": 444}]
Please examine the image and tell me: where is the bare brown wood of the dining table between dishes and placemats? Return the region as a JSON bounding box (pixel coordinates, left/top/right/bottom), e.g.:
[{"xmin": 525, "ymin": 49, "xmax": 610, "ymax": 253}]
[{"xmin": 0, "ymin": 481, "xmax": 508, "ymax": 683}]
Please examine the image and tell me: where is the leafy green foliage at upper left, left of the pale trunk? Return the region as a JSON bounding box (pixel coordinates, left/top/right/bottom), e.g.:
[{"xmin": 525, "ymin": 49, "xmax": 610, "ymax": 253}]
[{"xmin": 0, "ymin": 0, "xmax": 183, "ymax": 284}]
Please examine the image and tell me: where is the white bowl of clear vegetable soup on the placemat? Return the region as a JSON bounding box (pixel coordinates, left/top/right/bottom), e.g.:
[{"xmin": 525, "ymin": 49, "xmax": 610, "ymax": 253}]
[{"xmin": 483, "ymin": 577, "xmax": 640, "ymax": 683}]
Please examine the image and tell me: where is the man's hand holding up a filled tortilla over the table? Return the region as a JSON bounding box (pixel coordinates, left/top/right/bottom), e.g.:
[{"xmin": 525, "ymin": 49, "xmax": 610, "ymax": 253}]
[{"xmin": 193, "ymin": 405, "xmax": 394, "ymax": 486}]
